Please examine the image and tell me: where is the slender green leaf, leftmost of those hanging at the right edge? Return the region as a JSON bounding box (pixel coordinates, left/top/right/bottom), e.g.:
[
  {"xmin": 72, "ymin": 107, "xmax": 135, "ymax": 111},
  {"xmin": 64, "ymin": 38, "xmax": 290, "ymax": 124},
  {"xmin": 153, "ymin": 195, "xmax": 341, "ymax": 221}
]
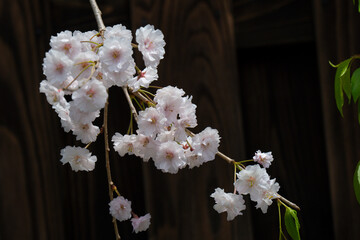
[{"xmin": 334, "ymin": 58, "xmax": 352, "ymax": 116}]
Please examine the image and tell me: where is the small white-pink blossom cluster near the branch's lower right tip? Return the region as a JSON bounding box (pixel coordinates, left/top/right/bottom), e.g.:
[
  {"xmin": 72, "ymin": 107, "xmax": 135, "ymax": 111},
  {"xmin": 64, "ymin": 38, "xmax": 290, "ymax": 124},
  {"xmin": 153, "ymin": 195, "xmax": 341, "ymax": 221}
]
[{"xmin": 211, "ymin": 150, "xmax": 280, "ymax": 221}]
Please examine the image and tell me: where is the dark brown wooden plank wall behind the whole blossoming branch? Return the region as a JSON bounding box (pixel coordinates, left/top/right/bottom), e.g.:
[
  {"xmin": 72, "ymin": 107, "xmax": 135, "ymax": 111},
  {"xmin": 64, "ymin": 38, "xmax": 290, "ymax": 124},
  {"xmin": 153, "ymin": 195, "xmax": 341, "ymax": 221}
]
[{"xmin": 0, "ymin": 0, "xmax": 360, "ymax": 240}]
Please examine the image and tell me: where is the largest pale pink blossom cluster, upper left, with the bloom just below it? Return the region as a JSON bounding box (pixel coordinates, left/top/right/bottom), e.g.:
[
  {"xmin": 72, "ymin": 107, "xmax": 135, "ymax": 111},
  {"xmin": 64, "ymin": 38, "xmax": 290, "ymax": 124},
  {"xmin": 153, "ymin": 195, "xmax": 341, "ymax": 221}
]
[{"xmin": 40, "ymin": 24, "xmax": 165, "ymax": 171}]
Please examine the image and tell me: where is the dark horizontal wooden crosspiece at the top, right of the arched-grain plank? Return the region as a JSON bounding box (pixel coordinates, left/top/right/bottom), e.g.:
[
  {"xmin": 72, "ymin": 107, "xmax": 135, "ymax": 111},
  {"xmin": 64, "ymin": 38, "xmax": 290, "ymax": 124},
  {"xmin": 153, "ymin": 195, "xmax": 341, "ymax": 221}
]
[{"xmin": 233, "ymin": 0, "xmax": 314, "ymax": 48}]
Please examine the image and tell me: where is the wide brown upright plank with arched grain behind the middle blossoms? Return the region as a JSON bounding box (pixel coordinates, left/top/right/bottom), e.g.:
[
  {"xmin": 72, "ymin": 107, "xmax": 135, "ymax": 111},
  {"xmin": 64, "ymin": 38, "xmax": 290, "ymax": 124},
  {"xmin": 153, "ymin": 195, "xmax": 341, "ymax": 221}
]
[{"xmin": 131, "ymin": 0, "xmax": 252, "ymax": 240}]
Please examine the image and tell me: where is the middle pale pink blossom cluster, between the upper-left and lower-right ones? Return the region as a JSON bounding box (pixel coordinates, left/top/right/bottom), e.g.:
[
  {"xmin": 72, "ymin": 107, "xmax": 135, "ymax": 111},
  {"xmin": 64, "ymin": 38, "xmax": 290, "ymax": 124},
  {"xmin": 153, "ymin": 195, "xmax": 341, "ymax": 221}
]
[{"xmin": 112, "ymin": 86, "xmax": 220, "ymax": 173}]
